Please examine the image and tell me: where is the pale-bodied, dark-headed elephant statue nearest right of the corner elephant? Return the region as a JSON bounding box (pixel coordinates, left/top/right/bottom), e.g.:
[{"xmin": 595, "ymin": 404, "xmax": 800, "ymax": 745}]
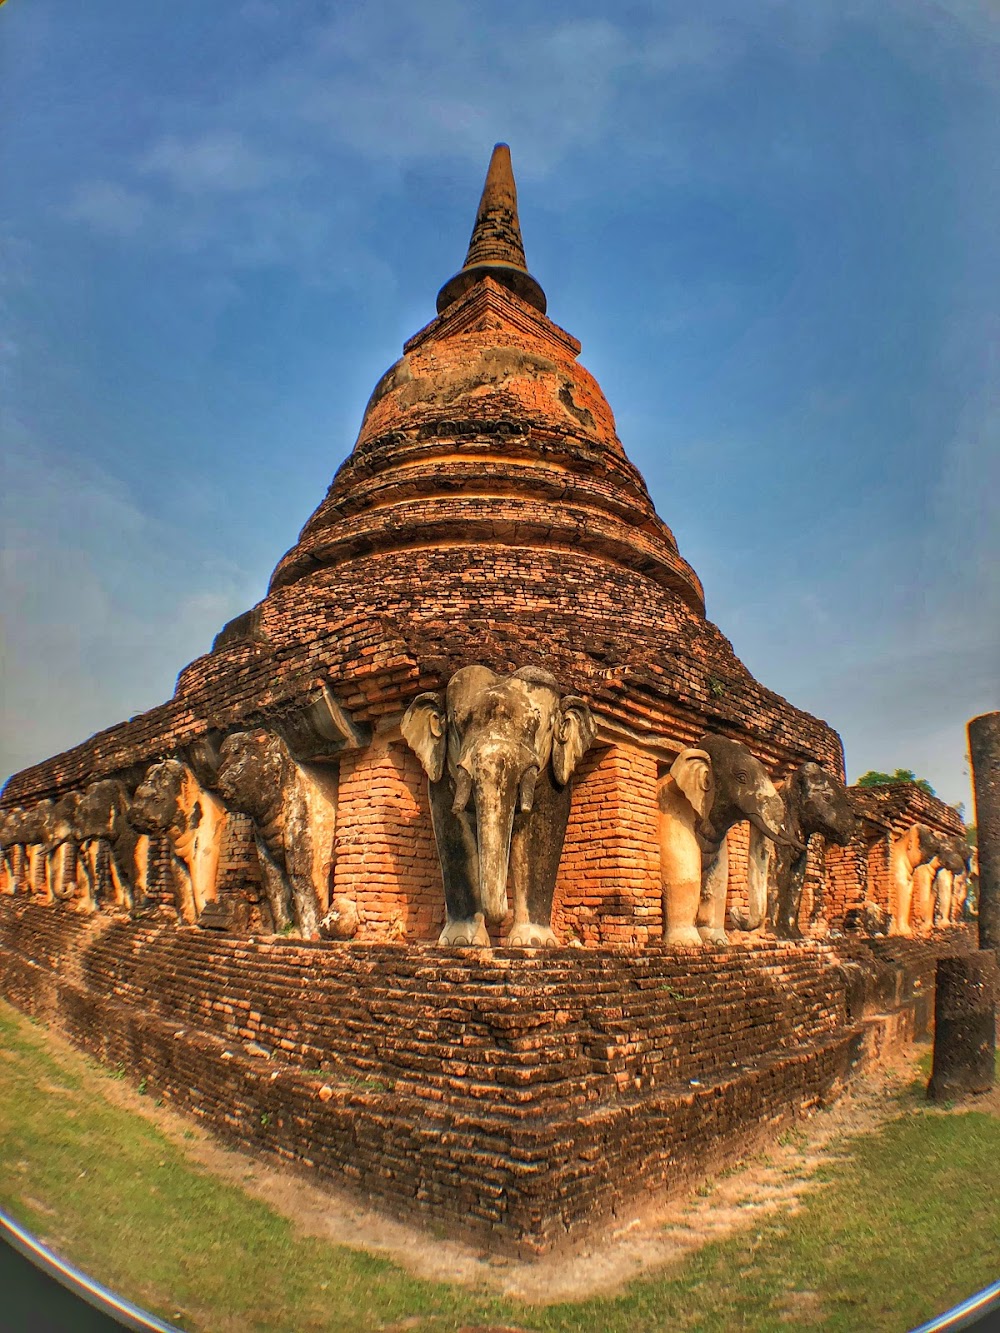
[{"xmin": 656, "ymin": 734, "xmax": 803, "ymax": 946}]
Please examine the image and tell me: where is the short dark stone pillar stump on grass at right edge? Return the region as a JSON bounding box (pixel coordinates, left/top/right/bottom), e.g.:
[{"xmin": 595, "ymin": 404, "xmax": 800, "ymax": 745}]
[{"xmin": 927, "ymin": 950, "xmax": 997, "ymax": 1101}]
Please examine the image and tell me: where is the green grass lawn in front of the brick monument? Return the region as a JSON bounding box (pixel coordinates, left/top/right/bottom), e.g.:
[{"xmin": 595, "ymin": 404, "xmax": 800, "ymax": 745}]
[{"xmin": 0, "ymin": 1004, "xmax": 1000, "ymax": 1333}]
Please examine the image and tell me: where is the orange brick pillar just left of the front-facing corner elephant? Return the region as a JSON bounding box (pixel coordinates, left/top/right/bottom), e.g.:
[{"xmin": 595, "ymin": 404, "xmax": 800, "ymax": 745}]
[{"xmin": 333, "ymin": 736, "xmax": 444, "ymax": 940}]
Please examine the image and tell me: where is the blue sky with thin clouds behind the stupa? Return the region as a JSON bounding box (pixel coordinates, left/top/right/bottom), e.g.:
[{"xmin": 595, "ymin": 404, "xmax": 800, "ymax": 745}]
[{"xmin": 0, "ymin": 0, "xmax": 1000, "ymax": 802}]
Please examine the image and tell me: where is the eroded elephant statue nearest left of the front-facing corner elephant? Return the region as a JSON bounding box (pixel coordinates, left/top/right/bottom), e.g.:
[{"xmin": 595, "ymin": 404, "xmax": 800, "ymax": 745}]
[{"xmin": 216, "ymin": 730, "xmax": 337, "ymax": 938}]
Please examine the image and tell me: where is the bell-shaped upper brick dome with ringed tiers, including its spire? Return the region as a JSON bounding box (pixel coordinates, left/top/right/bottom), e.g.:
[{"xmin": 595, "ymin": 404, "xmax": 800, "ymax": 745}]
[{"xmin": 271, "ymin": 145, "xmax": 704, "ymax": 615}]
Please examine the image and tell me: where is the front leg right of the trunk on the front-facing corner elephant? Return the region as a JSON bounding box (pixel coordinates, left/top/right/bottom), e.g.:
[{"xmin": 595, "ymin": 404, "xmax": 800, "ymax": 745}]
[{"xmin": 507, "ymin": 769, "xmax": 571, "ymax": 949}]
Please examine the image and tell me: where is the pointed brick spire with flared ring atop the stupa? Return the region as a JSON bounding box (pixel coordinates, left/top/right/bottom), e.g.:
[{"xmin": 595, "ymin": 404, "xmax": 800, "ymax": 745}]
[{"xmin": 437, "ymin": 144, "xmax": 545, "ymax": 315}]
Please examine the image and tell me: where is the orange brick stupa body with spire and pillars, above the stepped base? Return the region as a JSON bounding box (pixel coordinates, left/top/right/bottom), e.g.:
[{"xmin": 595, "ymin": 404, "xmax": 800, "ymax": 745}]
[{"xmin": 4, "ymin": 144, "xmax": 843, "ymax": 944}]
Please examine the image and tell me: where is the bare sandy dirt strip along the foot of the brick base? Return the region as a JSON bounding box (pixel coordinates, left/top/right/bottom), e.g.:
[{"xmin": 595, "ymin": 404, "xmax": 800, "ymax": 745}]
[{"xmin": 25, "ymin": 1033, "xmax": 1000, "ymax": 1304}]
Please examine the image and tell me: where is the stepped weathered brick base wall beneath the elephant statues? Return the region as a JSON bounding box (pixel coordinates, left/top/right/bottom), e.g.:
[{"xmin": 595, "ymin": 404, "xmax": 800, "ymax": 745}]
[{"xmin": 0, "ymin": 898, "xmax": 857, "ymax": 1253}]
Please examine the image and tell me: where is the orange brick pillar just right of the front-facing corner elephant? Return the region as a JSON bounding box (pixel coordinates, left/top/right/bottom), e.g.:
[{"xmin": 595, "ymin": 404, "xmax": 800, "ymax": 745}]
[{"xmin": 552, "ymin": 745, "xmax": 663, "ymax": 944}]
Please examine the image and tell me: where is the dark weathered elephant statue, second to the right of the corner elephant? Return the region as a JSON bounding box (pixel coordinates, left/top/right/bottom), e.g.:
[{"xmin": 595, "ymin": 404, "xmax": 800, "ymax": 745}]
[{"xmin": 768, "ymin": 760, "xmax": 859, "ymax": 940}]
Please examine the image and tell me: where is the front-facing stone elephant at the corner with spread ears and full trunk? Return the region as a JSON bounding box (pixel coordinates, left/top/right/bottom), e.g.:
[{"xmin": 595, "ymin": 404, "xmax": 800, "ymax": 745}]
[{"xmin": 400, "ymin": 665, "xmax": 596, "ymax": 948}]
